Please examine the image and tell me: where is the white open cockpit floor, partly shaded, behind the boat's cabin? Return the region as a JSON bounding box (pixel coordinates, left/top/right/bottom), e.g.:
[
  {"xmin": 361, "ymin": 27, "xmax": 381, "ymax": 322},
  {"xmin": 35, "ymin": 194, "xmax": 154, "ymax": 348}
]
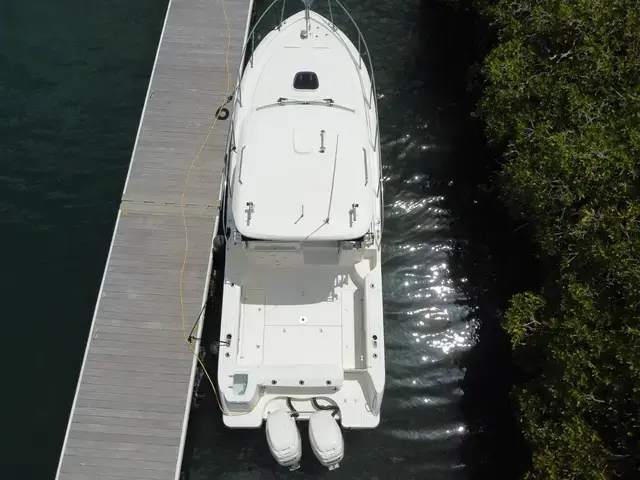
[{"xmin": 237, "ymin": 267, "xmax": 364, "ymax": 370}]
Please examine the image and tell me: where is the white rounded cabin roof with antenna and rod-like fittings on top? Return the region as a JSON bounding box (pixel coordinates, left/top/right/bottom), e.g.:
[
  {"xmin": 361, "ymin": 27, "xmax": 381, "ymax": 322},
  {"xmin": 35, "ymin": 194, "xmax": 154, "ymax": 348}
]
[{"xmin": 231, "ymin": 105, "xmax": 375, "ymax": 241}]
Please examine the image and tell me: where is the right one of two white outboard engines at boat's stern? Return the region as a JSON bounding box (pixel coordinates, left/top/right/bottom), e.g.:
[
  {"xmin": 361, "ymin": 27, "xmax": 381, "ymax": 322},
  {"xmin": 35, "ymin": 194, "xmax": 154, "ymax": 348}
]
[{"xmin": 309, "ymin": 410, "xmax": 344, "ymax": 470}]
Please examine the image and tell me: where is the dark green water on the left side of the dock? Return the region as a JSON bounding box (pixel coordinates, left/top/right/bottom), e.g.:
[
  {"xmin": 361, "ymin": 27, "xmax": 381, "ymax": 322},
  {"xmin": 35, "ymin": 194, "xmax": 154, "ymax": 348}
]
[{"xmin": 0, "ymin": 0, "xmax": 166, "ymax": 480}]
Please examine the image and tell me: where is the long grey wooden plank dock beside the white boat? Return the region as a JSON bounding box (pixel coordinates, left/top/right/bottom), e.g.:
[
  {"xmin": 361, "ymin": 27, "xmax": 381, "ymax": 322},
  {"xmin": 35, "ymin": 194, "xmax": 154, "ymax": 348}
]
[{"xmin": 56, "ymin": 0, "xmax": 253, "ymax": 480}]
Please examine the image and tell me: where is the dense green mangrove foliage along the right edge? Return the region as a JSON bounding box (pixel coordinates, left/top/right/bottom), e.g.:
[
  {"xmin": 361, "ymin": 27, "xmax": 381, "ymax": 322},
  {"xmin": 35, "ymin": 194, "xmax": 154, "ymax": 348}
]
[{"xmin": 475, "ymin": 0, "xmax": 640, "ymax": 480}]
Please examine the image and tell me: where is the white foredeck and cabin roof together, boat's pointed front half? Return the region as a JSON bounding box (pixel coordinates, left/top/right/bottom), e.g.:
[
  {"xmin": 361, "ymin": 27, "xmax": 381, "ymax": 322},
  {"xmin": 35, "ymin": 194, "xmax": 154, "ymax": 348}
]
[{"xmin": 230, "ymin": 12, "xmax": 380, "ymax": 241}]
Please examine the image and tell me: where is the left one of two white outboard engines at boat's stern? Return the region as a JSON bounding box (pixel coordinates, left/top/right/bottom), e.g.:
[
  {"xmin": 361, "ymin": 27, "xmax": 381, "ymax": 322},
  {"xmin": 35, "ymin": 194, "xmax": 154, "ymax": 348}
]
[{"xmin": 266, "ymin": 410, "xmax": 302, "ymax": 470}]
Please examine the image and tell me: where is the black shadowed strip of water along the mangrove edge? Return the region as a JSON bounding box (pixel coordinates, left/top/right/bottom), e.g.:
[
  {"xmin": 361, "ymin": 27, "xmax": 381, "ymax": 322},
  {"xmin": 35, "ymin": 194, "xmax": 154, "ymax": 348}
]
[{"xmin": 412, "ymin": 0, "xmax": 540, "ymax": 479}]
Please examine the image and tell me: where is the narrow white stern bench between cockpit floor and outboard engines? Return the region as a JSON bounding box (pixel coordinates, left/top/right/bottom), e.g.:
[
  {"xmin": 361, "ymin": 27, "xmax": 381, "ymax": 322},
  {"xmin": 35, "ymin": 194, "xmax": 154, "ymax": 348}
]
[{"xmin": 259, "ymin": 365, "xmax": 344, "ymax": 388}]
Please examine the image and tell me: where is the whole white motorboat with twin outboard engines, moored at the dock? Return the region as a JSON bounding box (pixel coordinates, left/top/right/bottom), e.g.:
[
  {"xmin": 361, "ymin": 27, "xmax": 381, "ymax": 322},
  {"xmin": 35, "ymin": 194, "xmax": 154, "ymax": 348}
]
[{"xmin": 218, "ymin": 0, "xmax": 385, "ymax": 469}]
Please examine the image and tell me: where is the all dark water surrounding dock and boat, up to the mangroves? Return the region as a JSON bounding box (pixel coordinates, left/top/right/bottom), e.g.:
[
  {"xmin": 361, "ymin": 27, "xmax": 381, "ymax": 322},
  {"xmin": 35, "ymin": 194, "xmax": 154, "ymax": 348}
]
[{"xmin": 0, "ymin": 0, "xmax": 532, "ymax": 480}]
